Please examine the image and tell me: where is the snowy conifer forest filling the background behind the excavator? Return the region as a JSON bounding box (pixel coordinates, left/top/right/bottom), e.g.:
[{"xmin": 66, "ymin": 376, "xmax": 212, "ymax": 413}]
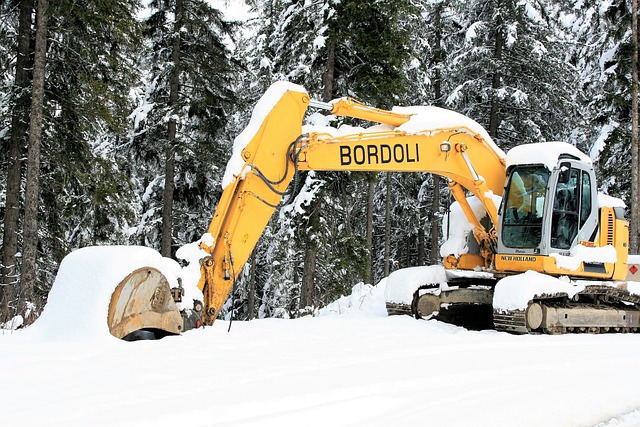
[{"xmin": 0, "ymin": 0, "xmax": 637, "ymax": 322}]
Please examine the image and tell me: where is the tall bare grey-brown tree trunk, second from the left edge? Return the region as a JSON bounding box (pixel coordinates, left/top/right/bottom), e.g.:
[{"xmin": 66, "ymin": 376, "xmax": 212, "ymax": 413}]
[{"xmin": 19, "ymin": 0, "xmax": 49, "ymax": 316}]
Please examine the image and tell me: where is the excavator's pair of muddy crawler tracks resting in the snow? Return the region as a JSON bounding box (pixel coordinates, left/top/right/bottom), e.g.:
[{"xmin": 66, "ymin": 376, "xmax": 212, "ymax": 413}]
[{"xmin": 387, "ymin": 279, "xmax": 640, "ymax": 335}]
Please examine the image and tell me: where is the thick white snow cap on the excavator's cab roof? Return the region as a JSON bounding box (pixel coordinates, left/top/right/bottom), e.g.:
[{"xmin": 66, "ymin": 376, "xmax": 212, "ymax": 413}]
[{"xmin": 507, "ymin": 141, "xmax": 592, "ymax": 170}]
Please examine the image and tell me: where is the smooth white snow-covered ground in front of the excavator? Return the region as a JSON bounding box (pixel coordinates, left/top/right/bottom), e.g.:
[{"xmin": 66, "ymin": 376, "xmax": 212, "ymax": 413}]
[{"xmin": 0, "ymin": 274, "xmax": 640, "ymax": 427}]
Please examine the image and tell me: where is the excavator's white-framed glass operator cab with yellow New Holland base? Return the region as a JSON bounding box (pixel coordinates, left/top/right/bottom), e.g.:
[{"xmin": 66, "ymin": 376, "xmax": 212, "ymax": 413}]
[{"xmin": 495, "ymin": 143, "xmax": 626, "ymax": 278}]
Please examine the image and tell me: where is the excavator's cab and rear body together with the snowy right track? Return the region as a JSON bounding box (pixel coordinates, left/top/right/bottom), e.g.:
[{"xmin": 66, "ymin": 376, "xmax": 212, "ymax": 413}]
[{"xmin": 493, "ymin": 147, "xmax": 640, "ymax": 334}]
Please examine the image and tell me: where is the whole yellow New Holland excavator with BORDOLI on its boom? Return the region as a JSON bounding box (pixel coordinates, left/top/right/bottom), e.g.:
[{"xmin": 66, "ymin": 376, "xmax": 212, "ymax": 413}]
[{"xmin": 108, "ymin": 82, "xmax": 640, "ymax": 338}]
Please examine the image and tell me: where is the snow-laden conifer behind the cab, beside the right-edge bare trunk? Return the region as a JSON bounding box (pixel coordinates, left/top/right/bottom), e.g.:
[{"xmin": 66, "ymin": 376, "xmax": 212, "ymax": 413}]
[{"xmin": 567, "ymin": 0, "xmax": 632, "ymax": 219}]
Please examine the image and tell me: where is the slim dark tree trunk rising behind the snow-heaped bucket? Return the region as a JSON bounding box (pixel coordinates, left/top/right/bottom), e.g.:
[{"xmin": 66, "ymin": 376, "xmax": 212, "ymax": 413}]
[{"xmin": 160, "ymin": 0, "xmax": 184, "ymax": 257}]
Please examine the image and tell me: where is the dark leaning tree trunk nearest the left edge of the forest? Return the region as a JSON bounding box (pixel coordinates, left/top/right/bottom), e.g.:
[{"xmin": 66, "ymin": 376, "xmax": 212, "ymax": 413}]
[{"xmin": 0, "ymin": 0, "xmax": 33, "ymax": 320}]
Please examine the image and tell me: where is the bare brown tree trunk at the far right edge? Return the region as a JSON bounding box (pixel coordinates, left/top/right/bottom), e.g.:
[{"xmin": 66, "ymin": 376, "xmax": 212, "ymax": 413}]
[{"xmin": 629, "ymin": 0, "xmax": 640, "ymax": 254}]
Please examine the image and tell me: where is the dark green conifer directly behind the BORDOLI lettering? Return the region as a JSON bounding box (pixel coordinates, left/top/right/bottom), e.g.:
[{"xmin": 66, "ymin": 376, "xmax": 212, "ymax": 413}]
[{"xmin": 316, "ymin": 0, "xmax": 415, "ymax": 290}]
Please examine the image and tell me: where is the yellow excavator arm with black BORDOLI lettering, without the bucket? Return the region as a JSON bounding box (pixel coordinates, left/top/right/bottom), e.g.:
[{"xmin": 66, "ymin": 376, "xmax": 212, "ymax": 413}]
[{"xmin": 198, "ymin": 83, "xmax": 505, "ymax": 324}]
